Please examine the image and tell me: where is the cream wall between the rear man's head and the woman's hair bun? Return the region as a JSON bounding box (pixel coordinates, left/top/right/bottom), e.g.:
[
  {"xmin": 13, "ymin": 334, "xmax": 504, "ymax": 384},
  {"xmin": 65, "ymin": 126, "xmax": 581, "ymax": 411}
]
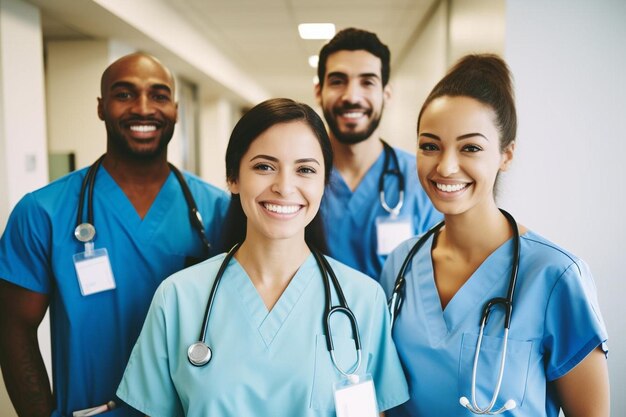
[{"xmin": 381, "ymin": 0, "xmax": 505, "ymax": 153}]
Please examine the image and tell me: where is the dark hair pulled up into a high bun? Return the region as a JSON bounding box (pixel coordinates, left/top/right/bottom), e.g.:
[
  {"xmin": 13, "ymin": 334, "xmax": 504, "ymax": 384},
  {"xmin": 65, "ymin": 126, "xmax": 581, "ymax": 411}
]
[{"xmin": 417, "ymin": 54, "xmax": 517, "ymax": 152}]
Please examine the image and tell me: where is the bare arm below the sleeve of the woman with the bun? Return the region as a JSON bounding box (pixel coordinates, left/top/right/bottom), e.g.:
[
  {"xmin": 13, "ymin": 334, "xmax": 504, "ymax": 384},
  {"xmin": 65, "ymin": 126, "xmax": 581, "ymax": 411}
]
[{"xmin": 554, "ymin": 347, "xmax": 610, "ymax": 417}]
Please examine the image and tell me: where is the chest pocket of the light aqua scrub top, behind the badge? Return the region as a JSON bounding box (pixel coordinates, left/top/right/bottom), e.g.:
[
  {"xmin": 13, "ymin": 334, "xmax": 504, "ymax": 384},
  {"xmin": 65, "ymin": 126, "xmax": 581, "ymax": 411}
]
[{"xmin": 310, "ymin": 332, "xmax": 360, "ymax": 415}]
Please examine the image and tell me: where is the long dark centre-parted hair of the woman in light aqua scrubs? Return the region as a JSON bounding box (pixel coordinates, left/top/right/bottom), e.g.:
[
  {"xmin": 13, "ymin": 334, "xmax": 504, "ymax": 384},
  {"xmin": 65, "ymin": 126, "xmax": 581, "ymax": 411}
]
[{"xmin": 222, "ymin": 98, "xmax": 333, "ymax": 253}]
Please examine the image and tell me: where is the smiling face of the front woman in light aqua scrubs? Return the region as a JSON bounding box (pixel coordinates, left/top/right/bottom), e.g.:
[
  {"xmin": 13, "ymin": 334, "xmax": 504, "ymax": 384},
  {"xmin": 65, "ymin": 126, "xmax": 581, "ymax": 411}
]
[{"xmin": 229, "ymin": 122, "xmax": 324, "ymax": 241}]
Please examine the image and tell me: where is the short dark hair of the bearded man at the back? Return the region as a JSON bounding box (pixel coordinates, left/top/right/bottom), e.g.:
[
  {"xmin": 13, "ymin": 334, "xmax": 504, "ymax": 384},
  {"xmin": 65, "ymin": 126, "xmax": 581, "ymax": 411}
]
[{"xmin": 317, "ymin": 28, "xmax": 391, "ymax": 87}]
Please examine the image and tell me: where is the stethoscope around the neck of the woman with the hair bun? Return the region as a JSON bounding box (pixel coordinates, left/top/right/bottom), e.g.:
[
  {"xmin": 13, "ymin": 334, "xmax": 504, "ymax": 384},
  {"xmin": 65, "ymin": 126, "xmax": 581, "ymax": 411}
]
[{"xmin": 389, "ymin": 209, "xmax": 520, "ymax": 414}]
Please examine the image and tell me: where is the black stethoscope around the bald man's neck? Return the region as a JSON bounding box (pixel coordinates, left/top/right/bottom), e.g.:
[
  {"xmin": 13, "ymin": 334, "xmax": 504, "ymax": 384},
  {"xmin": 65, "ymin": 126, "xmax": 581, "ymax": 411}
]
[{"xmin": 74, "ymin": 155, "xmax": 211, "ymax": 257}]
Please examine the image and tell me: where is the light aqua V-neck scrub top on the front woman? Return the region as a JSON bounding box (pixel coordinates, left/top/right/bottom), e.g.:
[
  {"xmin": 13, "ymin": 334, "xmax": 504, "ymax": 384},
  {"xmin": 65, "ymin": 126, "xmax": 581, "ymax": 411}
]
[{"xmin": 117, "ymin": 254, "xmax": 408, "ymax": 417}]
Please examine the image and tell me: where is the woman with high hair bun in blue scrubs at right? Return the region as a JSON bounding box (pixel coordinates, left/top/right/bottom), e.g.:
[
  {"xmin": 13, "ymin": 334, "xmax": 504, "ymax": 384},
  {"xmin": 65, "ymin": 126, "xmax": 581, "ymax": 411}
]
[{"xmin": 381, "ymin": 55, "xmax": 609, "ymax": 417}]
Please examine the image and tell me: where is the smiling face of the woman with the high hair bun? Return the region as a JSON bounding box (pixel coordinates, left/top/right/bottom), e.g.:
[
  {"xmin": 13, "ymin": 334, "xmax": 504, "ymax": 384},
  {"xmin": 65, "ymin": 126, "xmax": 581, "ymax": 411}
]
[{"xmin": 417, "ymin": 96, "xmax": 514, "ymax": 215}]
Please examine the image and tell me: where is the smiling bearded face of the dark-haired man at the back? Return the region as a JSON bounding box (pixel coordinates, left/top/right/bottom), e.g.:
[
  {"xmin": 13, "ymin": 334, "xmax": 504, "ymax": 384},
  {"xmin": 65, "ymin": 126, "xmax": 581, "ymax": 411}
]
[{"xmin": 315, "ymin": 50, "xmax": 390, "ymax": 144}]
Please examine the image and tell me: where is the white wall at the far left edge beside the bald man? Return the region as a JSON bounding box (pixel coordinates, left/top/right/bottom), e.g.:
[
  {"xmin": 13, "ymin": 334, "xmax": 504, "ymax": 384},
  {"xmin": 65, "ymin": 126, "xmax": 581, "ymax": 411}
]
[{"xmin": 0, "ymin": 0, "xmax": 50, "ymax": 417}]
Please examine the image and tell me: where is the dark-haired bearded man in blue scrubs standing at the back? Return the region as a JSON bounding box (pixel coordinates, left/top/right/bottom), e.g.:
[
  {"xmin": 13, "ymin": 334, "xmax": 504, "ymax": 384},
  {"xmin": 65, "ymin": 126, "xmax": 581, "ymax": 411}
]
[{"xmin": 315, "ymin": 28, "xmax": 441, "ymax": 279}]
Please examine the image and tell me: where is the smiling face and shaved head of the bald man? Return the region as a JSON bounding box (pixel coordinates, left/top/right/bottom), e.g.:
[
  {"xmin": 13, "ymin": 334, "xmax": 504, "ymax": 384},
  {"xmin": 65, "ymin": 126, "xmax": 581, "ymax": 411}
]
[{"xmin": 98, "ymin": 54, "xmax": 178, "ymax": 159}]
